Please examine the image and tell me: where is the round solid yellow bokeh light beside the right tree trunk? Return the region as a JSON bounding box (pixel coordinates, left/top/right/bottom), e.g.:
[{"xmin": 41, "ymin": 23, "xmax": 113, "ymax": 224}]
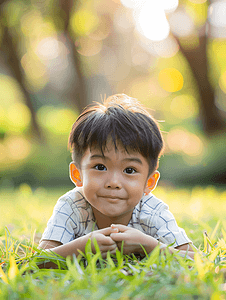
[{"xmin": 158, "ymin": 68, "xmax": 184, "ymax": 92}]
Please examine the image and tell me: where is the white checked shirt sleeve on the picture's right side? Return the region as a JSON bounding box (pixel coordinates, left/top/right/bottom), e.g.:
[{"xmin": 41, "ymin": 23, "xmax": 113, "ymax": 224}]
[{"xmin": 153, "ymin": 205, "xmax": 192, "ymax": 247}]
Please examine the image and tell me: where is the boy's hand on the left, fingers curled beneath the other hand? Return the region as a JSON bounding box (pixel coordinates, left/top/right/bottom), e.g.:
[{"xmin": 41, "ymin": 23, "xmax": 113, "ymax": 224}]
[{"xmin": 89, "ymin": 227, "xmax": 118, "ymax": 258}]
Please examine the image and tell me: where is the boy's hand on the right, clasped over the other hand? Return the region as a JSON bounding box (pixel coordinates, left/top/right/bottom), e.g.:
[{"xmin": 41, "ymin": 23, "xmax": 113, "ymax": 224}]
[{"xmin": 110, "ymin": 224, "xmax": 158, "ymax": 254}]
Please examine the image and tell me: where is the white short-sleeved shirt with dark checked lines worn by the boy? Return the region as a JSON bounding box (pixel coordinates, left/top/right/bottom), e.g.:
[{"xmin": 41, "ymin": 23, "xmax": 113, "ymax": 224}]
[{"xmin": 42, "ymin": 188, "xmax": 192, "ymax": 247}]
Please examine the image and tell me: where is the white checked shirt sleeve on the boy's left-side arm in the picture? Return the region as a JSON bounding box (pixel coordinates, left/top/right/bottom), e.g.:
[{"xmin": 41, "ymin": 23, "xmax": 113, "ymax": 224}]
[{"xmin": 42, "ymin": 199, "xmax": 79, "ymax": 244}]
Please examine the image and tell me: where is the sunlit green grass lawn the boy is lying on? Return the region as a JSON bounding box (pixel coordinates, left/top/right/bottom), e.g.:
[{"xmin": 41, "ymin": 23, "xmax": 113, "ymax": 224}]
[{"xmin": 0, "ymin": 184, "xmax": 226, "ymax": 300}]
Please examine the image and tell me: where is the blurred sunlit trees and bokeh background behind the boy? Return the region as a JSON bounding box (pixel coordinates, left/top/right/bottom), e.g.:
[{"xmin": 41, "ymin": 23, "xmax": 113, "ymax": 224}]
[{"xmin": 0, "ymin": 0, "xmax": 226, "ymax": 189}]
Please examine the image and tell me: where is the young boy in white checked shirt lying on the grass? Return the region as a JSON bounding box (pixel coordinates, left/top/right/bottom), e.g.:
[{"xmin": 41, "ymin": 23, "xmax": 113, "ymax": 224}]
[{"xmin": 39, "ymin": 94, "xmax": 193, "ymax": 257}]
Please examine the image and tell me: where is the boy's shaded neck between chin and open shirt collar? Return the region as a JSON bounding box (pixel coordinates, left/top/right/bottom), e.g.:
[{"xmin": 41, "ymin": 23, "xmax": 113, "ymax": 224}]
[{"xmin": 92, "ymin": 207, "xmax": 132, "ymax": 229}]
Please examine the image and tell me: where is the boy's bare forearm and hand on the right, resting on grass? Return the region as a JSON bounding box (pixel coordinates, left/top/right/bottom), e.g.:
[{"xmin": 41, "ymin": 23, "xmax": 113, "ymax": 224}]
[{"xmin": 110, "ymin": 225, "xmax": 194, "ymax": 258}]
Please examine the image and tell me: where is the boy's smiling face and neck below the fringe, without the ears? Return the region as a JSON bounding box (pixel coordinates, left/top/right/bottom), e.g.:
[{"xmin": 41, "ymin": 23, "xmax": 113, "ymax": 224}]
[{"xmin": 71, "ymin": 141, "xmax": 158, "ymax": 225}]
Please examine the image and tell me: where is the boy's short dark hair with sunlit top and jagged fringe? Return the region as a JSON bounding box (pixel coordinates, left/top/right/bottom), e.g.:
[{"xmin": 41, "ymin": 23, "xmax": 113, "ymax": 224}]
[{"xmin": 68, "ymin": 94, "xmax": 164, "ymax": 175}]
